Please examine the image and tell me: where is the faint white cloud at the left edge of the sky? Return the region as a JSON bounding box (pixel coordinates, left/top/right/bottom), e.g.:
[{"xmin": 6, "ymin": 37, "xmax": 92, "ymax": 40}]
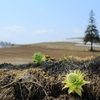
[{"xmin": 0, "ymin": 26, "xmax": 26, "ymax": 33}]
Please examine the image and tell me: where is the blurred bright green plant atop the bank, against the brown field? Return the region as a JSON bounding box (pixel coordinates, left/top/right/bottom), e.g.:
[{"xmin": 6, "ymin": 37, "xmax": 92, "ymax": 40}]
[{"xmin": 32, "ymin": 52, "xmax": 45, "ymax": 64}]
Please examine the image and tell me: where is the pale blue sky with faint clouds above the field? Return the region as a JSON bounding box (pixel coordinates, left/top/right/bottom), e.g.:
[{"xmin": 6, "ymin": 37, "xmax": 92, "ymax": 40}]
[{"xmin": 0, "ymin": 0, "xmax": 100, "ymax": 44}]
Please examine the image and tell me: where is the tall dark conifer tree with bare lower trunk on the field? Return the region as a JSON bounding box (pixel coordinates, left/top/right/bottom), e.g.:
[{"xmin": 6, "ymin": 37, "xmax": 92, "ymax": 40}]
[{"xmin": 84, "ymin": 10, "xmax": 100, "ymax": 51}]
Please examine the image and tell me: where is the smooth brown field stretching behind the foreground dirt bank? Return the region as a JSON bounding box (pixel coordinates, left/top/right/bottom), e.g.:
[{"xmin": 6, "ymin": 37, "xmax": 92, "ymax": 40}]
[{"xmin": 0, "ymin": 42, "xmax": 100, "ymax": 64}]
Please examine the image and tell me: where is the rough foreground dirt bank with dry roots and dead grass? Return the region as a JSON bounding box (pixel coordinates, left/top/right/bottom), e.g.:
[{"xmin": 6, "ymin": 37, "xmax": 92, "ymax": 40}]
[{"xmin": 0, "ymin": 56, "xmax": 100, "ymax": 100}]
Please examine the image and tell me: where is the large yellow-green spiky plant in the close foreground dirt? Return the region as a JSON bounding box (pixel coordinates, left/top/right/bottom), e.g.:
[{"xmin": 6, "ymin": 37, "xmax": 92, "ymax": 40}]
[{"xmin": 62, "ymin": 70, "xmax": 90, "ymax": 96}]
